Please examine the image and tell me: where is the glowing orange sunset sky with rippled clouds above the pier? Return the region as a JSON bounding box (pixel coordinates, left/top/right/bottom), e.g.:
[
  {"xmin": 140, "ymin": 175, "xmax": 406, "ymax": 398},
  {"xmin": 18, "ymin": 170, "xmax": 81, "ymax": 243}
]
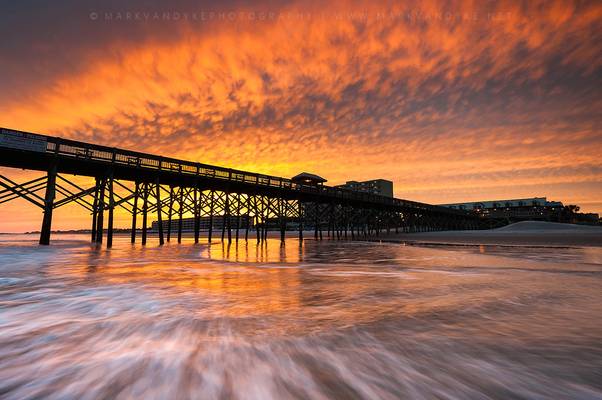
[{"xmin": 0, "ymin": 0, "xmax": 602, "ymax": 231}]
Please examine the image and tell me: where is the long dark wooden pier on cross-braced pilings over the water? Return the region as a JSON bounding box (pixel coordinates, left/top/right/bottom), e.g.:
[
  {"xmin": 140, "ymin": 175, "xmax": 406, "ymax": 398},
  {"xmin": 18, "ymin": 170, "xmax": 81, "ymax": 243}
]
[{"xmin": 0, "ymin": 128, "xmax": 479, "ymax": 247}]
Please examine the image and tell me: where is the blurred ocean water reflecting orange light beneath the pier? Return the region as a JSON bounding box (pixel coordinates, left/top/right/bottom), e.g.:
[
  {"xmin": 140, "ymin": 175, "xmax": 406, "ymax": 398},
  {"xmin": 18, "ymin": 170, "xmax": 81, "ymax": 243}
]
[{"xmin": 0, "ymin": 235, "xmax": 602, "ymax": 400}]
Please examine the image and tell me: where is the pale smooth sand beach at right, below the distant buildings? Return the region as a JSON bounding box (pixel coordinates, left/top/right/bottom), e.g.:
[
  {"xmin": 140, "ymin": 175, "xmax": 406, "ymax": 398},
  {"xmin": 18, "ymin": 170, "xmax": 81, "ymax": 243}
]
[{"xmin": 379, "ymin": 221, "xmax": 602, "ymax": 247}]
